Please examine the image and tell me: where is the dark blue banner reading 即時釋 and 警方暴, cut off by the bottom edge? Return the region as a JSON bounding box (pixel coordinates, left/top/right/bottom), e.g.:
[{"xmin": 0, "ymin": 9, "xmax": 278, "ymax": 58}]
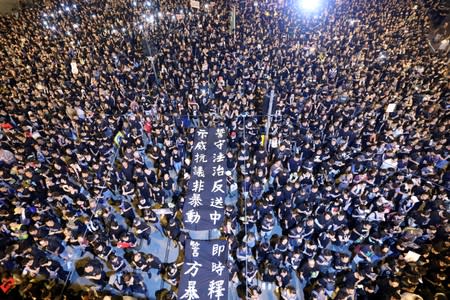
[{"xmin": 178, "ymin": 240, "xmax": 229, "ymax": 300}]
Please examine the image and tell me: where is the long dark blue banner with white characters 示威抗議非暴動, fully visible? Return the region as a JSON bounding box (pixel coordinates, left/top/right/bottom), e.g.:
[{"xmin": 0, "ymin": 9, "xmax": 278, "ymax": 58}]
[{"xmin": 183, "ymin": 128, "xmax": 227, "ymax": 230}]
